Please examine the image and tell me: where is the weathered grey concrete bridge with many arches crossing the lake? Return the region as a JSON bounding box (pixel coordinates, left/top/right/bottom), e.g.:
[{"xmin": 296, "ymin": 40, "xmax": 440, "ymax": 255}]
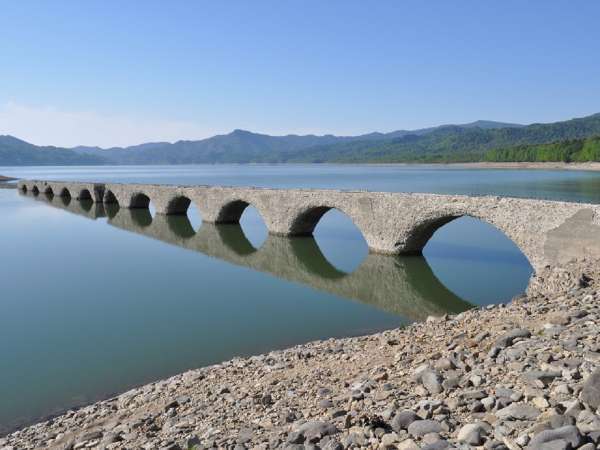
[{"xmin": 18, "ymin": 180, "xmax": 600, "ymax": 271}]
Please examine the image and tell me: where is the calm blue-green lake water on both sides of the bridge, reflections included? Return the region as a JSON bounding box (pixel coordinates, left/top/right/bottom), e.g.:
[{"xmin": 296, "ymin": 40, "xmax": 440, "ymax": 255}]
[{"xmin": 0, "ymin": 165, "xmax": 600, "ymax": 434}]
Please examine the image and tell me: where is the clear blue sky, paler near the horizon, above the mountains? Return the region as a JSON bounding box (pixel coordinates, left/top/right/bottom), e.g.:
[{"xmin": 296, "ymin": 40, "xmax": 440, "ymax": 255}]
[{"xmin": 0, "ymin": 0, "xmax": 600, "ymax": 147}]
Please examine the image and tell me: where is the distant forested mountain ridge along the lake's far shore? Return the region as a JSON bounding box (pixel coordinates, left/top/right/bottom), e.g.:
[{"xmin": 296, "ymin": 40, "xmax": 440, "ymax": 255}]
[{"xmin": 0, "ymin": 114, "xmax": 600, "ymax": 165}]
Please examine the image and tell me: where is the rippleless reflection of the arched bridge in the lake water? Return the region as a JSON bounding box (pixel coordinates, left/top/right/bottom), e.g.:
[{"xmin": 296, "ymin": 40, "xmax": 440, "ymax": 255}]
[{"xmin": 24, "ymin": 195, "xmax": 471, "ymax": 321}]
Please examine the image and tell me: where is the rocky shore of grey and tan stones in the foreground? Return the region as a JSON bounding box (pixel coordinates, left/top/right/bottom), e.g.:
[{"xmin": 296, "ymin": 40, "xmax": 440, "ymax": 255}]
[{"xmin": 0, "ymin": 261, "xmax": 600, "ymax": 450}]
